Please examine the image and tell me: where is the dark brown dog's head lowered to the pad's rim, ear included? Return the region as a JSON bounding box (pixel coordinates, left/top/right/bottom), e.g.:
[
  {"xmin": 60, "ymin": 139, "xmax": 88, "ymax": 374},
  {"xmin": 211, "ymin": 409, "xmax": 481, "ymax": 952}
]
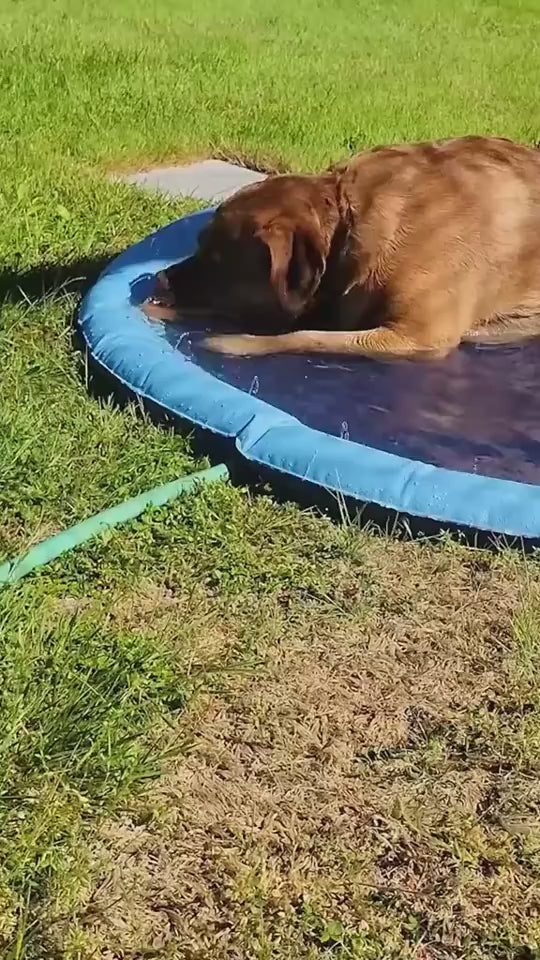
[{"xmin": 152, "ymin": 175, "xmax": 339, "ymax": 329}]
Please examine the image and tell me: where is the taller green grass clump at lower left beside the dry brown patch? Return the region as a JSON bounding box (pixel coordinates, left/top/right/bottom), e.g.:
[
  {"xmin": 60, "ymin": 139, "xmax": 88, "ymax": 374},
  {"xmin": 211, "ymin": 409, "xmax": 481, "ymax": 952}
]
[{"xmin": 0, "ymin": 588, "xmax": 187, "ymax": 946}]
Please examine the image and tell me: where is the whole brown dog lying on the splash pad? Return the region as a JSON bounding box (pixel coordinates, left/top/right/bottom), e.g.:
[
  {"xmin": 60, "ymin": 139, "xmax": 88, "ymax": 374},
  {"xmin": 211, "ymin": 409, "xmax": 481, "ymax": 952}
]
[{"xmin": 148, "ymin": 137, "xmax": 540, "ymax": 359}]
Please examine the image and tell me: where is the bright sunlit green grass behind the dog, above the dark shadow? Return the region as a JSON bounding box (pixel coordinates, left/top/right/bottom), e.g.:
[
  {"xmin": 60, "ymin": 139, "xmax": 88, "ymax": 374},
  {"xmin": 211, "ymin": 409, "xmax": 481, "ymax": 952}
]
[{"xmin": 0, "ymin": 0, "xmax": 540, "ymax": 264}]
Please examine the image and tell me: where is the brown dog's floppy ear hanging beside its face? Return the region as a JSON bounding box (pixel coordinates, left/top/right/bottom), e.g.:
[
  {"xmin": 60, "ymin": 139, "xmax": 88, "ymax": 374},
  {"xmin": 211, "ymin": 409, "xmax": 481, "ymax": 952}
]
[{"xmin": 258, "ymin": 223, "xmax": 326, "ymax": 315}]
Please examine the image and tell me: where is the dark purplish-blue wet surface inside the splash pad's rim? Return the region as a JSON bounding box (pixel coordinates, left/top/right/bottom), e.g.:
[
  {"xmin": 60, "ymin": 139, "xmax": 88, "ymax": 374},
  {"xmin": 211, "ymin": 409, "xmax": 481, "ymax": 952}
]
[{"xmin": 164, "ymin": 325, "xmax": 540, "ymax": 484}]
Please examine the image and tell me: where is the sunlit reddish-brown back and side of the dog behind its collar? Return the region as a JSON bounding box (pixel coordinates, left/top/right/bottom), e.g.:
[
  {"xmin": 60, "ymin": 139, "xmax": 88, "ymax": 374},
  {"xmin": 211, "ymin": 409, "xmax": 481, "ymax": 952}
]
[{"xmin": 336, "ymin": 137, "xmax": 540, "ymax": 340}]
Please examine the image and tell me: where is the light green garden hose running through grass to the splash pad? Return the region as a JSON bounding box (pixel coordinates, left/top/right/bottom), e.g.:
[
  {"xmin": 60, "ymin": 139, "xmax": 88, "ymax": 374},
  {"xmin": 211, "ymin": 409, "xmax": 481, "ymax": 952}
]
[{"xmin": 0, "ymin": 463, "xmax": 229, "ymax": 587}]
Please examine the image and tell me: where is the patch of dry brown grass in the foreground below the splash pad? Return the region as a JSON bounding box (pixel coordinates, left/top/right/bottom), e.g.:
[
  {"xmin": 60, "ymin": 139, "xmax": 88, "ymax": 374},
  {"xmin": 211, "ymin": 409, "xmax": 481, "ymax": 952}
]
[{"xmin": 50, "ymin": 534, "xmax": 540, "ymax": 960}]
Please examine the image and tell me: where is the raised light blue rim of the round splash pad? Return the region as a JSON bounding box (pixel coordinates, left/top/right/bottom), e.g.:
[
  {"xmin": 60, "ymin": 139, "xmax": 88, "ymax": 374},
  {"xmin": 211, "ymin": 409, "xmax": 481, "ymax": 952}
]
[{"xmin": 78, "ymin": 209, "xmax": 540, "ymax": 539}]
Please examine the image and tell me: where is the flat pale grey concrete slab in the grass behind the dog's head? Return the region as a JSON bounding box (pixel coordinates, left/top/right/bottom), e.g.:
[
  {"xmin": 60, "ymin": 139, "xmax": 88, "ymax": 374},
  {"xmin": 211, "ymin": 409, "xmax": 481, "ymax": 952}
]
[{"xmin": 120, "ymin": 160, "xmax": 266, "ymax": 203}]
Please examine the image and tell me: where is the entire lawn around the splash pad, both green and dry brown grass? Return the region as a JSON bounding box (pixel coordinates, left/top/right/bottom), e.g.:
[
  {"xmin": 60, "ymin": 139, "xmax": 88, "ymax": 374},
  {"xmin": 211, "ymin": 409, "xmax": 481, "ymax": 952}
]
[{"xmin": 0, "ymin": 0, "xmax": 540, "ymax": 960}]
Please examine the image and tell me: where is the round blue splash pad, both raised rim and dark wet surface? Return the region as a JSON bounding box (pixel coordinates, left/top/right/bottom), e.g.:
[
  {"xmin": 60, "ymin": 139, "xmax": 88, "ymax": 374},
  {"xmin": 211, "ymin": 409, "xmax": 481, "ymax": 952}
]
[{"xmin": 79, "ymin": 210, "xmax": 540, "ymax": 538}]
